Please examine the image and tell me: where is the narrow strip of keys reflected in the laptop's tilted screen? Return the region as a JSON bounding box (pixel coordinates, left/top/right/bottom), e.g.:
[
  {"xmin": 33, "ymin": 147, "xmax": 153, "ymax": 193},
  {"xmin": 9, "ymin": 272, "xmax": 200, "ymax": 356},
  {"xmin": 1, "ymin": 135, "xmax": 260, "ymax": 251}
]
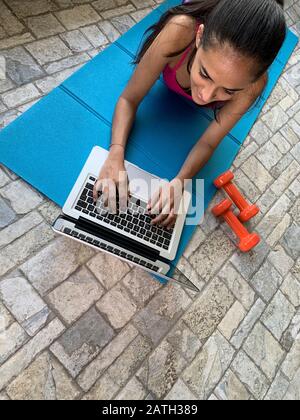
[{"xmin": 63, "ymin": 227, "xmax": 159, "ymax": 272}]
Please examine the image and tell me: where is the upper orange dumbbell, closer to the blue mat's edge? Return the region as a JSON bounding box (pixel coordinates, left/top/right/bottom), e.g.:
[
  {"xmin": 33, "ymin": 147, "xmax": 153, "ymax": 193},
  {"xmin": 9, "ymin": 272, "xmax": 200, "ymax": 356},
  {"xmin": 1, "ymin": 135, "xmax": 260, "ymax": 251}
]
[{"xmin": 214, "ymin": 171, "xmax": 259, "ymax": 222}]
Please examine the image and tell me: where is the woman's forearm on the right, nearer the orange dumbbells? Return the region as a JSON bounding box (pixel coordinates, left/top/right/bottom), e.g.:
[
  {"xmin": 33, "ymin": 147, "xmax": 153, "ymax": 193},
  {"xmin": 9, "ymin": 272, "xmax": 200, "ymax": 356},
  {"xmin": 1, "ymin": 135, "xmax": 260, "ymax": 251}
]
[{"xmin": 177, "ymin": 139, "xmax": 214, "ymax": 182}]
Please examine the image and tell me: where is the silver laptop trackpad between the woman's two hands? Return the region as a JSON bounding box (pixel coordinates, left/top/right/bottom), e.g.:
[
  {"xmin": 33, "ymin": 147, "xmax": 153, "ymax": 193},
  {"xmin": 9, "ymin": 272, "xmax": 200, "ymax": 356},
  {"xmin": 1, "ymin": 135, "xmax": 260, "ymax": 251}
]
[{"xmin": 125, "ymin": 163, "xmax": 166, "ymax": 201}]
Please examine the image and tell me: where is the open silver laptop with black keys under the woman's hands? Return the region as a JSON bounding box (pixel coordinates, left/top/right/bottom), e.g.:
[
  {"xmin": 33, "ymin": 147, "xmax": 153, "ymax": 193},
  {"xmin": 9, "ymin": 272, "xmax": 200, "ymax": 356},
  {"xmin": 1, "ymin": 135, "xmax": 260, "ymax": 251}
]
[{"xmin": 52, "ymin": 146, "xmax": 199, "ymax": 292}]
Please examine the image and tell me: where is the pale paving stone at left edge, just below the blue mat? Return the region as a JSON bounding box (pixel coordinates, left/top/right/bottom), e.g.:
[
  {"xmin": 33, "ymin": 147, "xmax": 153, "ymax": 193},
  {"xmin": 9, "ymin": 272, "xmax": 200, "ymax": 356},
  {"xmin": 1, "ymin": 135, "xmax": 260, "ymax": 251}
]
[{"xmin": 0, "ymin": 180, "xmax": 43, "ymax": 214}]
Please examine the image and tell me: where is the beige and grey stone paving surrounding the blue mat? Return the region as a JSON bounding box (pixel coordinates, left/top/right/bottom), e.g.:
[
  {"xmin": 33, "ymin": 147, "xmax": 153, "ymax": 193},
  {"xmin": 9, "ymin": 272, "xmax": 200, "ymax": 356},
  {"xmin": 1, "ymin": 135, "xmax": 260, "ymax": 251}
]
[{"xmin": 0, "ymin": 0, "xmax": 300, "ymax": 400}]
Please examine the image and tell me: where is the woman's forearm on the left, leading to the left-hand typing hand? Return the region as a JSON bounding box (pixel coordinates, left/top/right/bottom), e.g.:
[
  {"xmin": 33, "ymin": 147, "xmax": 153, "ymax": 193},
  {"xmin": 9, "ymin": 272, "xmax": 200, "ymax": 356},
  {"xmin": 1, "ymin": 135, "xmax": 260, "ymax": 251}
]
[{"xmin": 110, "ymin": 96, "xmax": 137, "ymax": 159}]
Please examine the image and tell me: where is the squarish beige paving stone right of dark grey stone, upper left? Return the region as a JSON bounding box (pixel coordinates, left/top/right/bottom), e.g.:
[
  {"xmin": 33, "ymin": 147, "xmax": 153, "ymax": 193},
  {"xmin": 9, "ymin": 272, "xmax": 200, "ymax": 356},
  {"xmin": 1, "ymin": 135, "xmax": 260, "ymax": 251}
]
[{"xmin": 26, "ymin": 36, "xmax": 72, "ymax": 65}]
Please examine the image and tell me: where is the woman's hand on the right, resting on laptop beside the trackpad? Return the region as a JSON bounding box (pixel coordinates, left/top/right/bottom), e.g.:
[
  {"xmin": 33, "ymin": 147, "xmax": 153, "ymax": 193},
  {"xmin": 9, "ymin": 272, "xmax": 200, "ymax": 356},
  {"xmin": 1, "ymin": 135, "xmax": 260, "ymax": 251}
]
[{"xmin": 147, "ymin": 178, "xmax": 184, "ymax": 229}]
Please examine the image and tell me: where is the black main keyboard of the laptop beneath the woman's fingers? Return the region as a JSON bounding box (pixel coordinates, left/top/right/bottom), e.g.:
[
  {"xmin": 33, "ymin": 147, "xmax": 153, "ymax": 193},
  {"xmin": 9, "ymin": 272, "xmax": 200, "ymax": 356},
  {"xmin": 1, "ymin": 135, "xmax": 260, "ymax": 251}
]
[{"xmin": 75, "ymin": 176, "xmax": 173, "ymax": 250}]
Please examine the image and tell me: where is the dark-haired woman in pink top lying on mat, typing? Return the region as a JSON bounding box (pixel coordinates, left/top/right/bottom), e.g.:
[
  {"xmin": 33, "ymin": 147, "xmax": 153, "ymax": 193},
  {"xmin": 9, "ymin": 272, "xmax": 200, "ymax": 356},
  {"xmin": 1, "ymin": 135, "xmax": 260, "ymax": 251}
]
[{"xmin": 94, "ymin": 0, "xmax": 286, "ymax": 228}]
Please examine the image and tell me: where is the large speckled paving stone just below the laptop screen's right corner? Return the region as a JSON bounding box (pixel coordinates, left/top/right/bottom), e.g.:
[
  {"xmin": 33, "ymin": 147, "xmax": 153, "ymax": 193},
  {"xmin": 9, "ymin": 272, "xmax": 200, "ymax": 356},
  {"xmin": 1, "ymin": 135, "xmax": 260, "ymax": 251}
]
[{"xmin": 183, "ymin": 278, "xmax": 234, "ymax": 340}]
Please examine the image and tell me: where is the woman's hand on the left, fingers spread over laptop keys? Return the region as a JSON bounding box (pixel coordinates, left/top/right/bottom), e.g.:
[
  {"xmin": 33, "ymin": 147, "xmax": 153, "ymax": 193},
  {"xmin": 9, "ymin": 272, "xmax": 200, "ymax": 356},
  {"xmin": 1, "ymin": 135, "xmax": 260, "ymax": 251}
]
[{"xmin": 93, "ymin": 153, "xmax": 130, "ymax": 214}]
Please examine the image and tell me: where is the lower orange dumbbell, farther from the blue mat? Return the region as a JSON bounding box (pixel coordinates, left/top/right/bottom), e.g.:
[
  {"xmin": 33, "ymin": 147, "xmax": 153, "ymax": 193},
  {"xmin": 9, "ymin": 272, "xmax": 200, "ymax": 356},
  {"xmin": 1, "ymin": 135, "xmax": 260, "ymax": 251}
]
[{"xmin": 212, "ymin": 199, "xmax": 260, "ymax": 252}]
